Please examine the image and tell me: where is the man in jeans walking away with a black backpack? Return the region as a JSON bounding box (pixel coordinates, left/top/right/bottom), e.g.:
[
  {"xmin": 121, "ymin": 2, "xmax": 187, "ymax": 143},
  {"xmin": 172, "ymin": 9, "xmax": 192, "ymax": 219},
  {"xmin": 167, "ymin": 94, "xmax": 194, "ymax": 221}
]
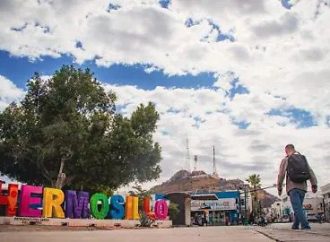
[{"xmin": 277, "ymin": 144, "xmax": 317, "ymax": 229}]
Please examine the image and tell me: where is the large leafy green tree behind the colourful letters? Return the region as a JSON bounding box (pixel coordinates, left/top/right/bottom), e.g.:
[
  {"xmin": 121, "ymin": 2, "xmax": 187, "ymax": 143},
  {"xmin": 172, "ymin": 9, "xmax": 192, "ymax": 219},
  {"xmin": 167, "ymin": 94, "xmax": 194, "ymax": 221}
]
[{"xmin": 0, "ymin": 66, "xmax": 161, "ymax": 191}]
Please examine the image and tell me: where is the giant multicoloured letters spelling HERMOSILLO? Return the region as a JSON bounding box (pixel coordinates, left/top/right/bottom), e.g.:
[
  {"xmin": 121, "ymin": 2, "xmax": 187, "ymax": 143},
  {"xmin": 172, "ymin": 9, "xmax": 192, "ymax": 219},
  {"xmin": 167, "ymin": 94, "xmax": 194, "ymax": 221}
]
[{"xmin": 0, "ymin": 181, "xmax": 168, "ymax": 220}]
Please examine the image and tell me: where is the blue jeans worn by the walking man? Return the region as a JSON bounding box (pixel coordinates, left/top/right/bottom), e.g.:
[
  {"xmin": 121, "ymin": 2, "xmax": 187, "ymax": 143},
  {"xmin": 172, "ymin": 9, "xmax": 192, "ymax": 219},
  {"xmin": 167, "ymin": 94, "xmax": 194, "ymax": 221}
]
[{"xmin": 289, "ymin": 188, "xmax": 310, "ymax": 229}]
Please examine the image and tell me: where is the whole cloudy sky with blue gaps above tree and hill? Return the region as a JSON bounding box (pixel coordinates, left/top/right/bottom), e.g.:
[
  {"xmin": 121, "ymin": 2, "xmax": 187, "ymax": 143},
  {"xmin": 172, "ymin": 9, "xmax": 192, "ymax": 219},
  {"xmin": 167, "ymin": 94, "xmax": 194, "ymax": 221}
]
[{"xmin": 0, "ymin": 0, "xmax": 330, "ymax": 195}]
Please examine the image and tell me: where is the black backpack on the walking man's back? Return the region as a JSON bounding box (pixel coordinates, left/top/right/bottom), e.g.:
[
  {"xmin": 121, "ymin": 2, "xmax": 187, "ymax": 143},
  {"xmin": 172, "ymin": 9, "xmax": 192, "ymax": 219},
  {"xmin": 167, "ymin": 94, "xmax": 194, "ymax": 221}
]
[{"xmin": 287, "ymin": 154, "xmax": 310, "ymax": 183}]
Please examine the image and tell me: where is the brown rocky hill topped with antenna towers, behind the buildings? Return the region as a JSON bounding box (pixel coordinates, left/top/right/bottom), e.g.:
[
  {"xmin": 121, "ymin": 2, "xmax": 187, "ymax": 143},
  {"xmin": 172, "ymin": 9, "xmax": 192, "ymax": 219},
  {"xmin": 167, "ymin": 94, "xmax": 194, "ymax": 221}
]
[{"xmin": 151, "ymin": 170, "xmax": 278, "ymax": 208}]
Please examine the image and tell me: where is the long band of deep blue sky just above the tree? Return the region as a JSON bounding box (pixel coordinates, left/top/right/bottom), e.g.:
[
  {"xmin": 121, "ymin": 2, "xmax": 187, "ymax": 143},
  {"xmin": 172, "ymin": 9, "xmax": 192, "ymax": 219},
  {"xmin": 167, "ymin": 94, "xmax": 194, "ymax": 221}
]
[{"xmin": 0, "ymin": 51, "xmax": 215, "ymax": 89}]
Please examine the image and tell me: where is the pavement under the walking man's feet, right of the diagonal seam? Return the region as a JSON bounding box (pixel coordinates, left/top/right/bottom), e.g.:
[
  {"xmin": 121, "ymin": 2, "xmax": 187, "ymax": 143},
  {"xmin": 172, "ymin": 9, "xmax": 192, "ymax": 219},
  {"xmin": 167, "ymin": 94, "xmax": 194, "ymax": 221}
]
[{"xmin": 254, "ymin": 223, "xmax": 330, "ymax": 242}]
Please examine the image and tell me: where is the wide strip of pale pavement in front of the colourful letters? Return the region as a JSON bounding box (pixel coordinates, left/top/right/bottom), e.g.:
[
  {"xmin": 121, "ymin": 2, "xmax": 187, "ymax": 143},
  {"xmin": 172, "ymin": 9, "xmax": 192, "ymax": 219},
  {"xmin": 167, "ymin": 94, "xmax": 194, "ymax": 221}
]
[{"xmin": 0, "ymin": 226, "xmax": 273, "ymax": 242}]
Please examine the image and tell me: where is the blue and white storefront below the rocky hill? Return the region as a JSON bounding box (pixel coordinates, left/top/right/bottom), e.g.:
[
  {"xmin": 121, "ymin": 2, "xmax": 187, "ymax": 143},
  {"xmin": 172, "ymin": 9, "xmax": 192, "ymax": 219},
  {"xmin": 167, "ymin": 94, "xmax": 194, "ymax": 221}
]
[{"xmin": 191, "ymin": 191, "xmax": 241, "ymax": 225}]
